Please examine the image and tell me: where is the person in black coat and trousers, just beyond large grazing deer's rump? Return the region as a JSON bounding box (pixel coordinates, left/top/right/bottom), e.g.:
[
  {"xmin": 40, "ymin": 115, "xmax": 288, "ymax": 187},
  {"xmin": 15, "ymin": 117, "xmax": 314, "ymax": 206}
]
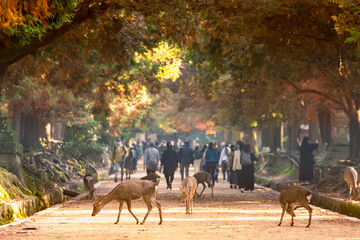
[{"xmin": 161, "ymin": 142, "xmax": 178, "ymax": 189}]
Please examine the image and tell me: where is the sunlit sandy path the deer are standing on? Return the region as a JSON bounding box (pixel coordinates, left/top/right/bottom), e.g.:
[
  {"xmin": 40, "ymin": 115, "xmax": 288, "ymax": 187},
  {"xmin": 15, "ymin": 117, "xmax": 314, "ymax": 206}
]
[{"xmin": 0, "ymin": 164, "xmax": 360, "ymax": 240}]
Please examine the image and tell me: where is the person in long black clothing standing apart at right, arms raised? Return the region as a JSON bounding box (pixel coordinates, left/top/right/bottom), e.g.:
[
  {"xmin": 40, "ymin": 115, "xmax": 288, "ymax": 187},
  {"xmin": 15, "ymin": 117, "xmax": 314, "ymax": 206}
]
[{"xmin": 299, "ymin": 137, "xmax": 318, "ymax": 184}]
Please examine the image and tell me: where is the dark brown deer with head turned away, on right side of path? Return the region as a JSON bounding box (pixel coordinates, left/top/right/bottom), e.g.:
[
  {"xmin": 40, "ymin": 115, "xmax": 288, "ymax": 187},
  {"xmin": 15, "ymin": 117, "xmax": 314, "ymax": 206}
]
[{"xmin": 279, "ymin": 186, "xmax": 312, "ymax": 227}]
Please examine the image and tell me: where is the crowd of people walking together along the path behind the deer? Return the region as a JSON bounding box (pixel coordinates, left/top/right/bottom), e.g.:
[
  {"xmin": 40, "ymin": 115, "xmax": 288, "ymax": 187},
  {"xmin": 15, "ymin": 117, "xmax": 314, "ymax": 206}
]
[{"xmin": 111, "ymin": 138, "xmax": 257, "ymax": 192}]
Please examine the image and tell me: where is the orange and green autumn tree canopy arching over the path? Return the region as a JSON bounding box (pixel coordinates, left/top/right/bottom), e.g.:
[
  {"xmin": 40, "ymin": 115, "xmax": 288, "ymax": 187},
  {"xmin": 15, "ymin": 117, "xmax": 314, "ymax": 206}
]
[{"xmin": 0, "ymin": 0, "xmax": 360, "ymax": 156}]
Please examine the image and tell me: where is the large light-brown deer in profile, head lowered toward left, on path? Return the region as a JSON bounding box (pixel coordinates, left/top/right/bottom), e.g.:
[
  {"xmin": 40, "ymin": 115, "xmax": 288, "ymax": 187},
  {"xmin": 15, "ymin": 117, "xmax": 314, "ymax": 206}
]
[{"xmin": 92, "ymin": 180, "xmax": 162, "ymax": 225}]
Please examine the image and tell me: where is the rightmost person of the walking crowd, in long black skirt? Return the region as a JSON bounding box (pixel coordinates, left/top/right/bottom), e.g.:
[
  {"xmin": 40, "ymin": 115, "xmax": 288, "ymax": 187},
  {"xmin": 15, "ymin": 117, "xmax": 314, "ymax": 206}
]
[{"xmin": 241, "ymin": 143, "xmax": 257, "ymax": 191}]
